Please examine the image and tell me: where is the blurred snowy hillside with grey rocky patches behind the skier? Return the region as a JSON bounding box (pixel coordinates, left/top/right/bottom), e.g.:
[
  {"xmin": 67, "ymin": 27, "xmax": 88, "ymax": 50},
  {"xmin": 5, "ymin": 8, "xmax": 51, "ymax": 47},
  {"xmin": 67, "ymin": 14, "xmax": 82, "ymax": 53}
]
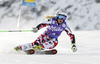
[{"xmin": 0, "ymin": 0, "xmax": 100, "ymax": 30}]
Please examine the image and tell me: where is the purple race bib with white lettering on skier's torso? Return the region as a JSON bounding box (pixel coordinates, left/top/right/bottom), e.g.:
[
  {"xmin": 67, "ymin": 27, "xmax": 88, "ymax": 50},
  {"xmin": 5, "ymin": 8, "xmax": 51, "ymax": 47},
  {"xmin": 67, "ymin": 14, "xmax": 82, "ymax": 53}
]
[{"xmin": 47, "ymin": 18, "xmax": 67, "ymax": 38}]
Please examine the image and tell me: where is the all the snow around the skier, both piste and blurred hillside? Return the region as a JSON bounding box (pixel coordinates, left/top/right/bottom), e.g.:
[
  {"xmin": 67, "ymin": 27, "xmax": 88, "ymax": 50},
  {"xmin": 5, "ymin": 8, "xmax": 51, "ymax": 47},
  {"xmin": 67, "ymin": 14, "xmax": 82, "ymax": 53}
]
[{"xmin": 0, "ymin": 0, "xmax": 100, "ymax": 64}]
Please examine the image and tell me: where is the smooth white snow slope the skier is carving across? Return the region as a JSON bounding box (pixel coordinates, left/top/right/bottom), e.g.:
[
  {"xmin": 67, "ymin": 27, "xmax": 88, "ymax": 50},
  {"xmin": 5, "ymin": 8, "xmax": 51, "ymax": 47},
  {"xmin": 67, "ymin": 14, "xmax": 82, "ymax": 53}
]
[{"xmin": 0, "ymin": 28, "xmax": 100, "ymax": 64}]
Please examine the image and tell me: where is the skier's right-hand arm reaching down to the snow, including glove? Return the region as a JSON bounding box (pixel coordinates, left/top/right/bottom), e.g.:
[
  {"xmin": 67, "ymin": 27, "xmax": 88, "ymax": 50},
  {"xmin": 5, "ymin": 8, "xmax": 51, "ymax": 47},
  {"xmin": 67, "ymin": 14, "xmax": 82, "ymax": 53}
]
[{"xmin": 65, "ymin": 26, "xmax": 77, "ymax": 52}]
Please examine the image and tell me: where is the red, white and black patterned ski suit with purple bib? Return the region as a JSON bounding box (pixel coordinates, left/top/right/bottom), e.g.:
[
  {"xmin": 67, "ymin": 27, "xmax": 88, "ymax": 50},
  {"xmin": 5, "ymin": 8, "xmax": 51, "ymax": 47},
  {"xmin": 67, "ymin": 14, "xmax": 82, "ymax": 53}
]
[{"xmin": 20, "ymin": 18, "xmax": 75, "ymax": 50}]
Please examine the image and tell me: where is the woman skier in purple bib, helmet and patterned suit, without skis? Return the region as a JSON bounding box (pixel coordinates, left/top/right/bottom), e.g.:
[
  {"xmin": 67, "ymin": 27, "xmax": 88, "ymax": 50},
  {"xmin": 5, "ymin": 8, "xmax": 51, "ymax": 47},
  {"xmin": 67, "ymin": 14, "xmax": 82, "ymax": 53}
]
[{"xmin": 15, "ymin": 9, "xmax": 77, "ymax": 52}]
